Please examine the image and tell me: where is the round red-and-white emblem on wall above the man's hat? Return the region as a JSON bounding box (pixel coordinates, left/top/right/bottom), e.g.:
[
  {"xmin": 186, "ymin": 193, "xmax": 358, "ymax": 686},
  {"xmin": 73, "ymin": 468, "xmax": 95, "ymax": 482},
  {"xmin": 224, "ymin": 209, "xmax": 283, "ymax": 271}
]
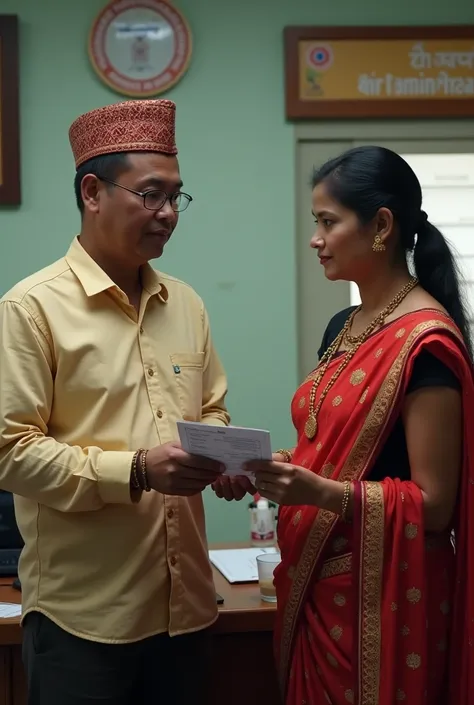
[{"xmin": 89, "ymin": 0, "xmax": 192, "ymax": 98}]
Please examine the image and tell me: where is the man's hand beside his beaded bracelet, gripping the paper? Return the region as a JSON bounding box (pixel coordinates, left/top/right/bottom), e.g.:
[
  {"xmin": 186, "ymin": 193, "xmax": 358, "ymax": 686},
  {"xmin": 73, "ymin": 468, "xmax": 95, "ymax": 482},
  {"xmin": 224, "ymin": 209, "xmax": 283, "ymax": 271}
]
[{"xmin": 146, "ymin": 443, "xmax": 224, "ymax": 497}]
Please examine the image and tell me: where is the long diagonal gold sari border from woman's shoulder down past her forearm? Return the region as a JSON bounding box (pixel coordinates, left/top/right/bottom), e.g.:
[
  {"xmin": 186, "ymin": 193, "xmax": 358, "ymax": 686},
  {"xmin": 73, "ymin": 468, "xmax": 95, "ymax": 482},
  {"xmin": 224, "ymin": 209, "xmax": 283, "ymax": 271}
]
[{"xmin": 279, "ymin": 319, "xmax": 462, "ymax": 693}]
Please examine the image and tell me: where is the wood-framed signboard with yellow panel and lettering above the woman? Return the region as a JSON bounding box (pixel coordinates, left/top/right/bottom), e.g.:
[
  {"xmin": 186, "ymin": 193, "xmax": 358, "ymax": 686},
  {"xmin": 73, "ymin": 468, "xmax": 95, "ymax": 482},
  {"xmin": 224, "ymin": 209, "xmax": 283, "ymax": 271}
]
[{"xmin": 284, "ymin": 25, "xmax": 474, "ymax": 120}]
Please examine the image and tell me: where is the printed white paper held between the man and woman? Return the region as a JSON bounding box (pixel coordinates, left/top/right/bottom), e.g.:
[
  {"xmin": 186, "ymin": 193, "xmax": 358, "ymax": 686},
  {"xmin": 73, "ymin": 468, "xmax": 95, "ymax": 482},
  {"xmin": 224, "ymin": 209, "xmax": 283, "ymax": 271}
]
[{"xmin": 177, "ymin": 421, "xmax": 272, "ymax": 476}]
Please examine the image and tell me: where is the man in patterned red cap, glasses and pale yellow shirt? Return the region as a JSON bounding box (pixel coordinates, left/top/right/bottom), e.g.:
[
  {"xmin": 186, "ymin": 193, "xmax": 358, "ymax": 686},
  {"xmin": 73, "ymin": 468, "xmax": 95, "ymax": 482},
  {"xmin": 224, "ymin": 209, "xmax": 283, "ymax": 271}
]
[{"xmin": 0, "ymin": 100, "xmax": 245, "ymax": 705}]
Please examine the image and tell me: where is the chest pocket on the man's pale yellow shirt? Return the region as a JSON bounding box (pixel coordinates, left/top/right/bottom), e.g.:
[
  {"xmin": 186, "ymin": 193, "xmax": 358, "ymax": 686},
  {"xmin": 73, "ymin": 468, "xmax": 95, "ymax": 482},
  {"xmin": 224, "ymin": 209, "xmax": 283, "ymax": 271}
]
[{"xmin": 170, "ymin": 352, "xmax": 204, "ymax": 421}]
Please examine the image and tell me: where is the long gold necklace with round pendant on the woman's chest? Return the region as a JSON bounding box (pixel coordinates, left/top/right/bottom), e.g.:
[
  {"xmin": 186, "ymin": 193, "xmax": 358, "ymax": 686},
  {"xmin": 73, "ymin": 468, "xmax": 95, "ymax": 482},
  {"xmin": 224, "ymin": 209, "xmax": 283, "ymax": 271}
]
[{"xmin": 304, "ymin": 277, "xmax": 418, "ymax": 440}]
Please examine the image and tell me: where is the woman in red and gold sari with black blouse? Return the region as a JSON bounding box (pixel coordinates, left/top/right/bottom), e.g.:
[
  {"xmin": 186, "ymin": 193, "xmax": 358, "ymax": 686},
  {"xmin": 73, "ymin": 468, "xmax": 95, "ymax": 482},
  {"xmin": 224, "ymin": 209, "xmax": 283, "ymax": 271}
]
[{"xmin": 247, "ymin": 147, "xmax": 474, "ymax": 705}]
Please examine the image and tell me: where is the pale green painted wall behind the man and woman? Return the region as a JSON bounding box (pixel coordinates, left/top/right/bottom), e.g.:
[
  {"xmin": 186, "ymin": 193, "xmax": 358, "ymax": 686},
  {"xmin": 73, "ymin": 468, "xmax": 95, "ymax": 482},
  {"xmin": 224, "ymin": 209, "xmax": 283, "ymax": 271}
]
[{"xmin": 0, "ymin": 0, "xmax": 474, "ymax": 541}]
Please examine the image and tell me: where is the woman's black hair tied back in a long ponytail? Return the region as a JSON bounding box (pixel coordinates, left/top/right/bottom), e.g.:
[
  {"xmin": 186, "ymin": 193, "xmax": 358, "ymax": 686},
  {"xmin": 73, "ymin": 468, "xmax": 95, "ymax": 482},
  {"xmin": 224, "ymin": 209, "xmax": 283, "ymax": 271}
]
[{"xmin": 312, "ymin": 146, "xmax": 472, "ymax": 353}]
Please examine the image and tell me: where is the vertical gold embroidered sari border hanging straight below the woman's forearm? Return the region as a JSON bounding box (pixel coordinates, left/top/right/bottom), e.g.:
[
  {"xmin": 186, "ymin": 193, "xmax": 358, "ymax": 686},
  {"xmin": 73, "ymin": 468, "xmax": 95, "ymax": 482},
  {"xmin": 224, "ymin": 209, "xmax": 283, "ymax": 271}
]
[{"xmin": 358, "ymin": 482, "xmax": 385, "ymax": 705}]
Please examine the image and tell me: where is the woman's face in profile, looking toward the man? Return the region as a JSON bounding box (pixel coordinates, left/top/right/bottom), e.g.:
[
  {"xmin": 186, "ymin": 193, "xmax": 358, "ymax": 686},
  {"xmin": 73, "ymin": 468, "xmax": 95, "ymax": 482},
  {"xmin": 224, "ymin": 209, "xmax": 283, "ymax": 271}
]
[{"xmin": 310, "ymin": 182, "xmax": 380, "ymax": 283}]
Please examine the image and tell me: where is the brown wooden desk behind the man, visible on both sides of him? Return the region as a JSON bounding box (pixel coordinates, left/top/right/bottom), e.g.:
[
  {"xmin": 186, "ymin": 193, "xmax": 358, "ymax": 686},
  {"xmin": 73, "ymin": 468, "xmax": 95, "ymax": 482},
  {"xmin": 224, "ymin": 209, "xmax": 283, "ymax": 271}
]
[{"xmin": 0, "ymin": 560, "xmax": 281, "ymax": 705}]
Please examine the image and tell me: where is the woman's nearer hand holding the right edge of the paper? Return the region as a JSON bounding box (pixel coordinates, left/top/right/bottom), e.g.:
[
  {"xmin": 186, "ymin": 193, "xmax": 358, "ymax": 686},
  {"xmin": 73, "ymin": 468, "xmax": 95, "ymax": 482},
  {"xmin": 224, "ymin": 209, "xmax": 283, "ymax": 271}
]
[{"xmin": 245, "ymin": 453, "xmax": 324, "ymax": 506}]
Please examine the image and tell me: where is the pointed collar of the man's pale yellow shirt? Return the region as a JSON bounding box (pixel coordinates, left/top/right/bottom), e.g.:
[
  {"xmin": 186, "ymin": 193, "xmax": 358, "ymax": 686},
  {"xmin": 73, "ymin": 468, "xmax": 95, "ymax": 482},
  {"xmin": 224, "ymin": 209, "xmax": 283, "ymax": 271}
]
[{"xmin": 66, "ymin": 237, "xmax": 169, "ymax": 303}]
